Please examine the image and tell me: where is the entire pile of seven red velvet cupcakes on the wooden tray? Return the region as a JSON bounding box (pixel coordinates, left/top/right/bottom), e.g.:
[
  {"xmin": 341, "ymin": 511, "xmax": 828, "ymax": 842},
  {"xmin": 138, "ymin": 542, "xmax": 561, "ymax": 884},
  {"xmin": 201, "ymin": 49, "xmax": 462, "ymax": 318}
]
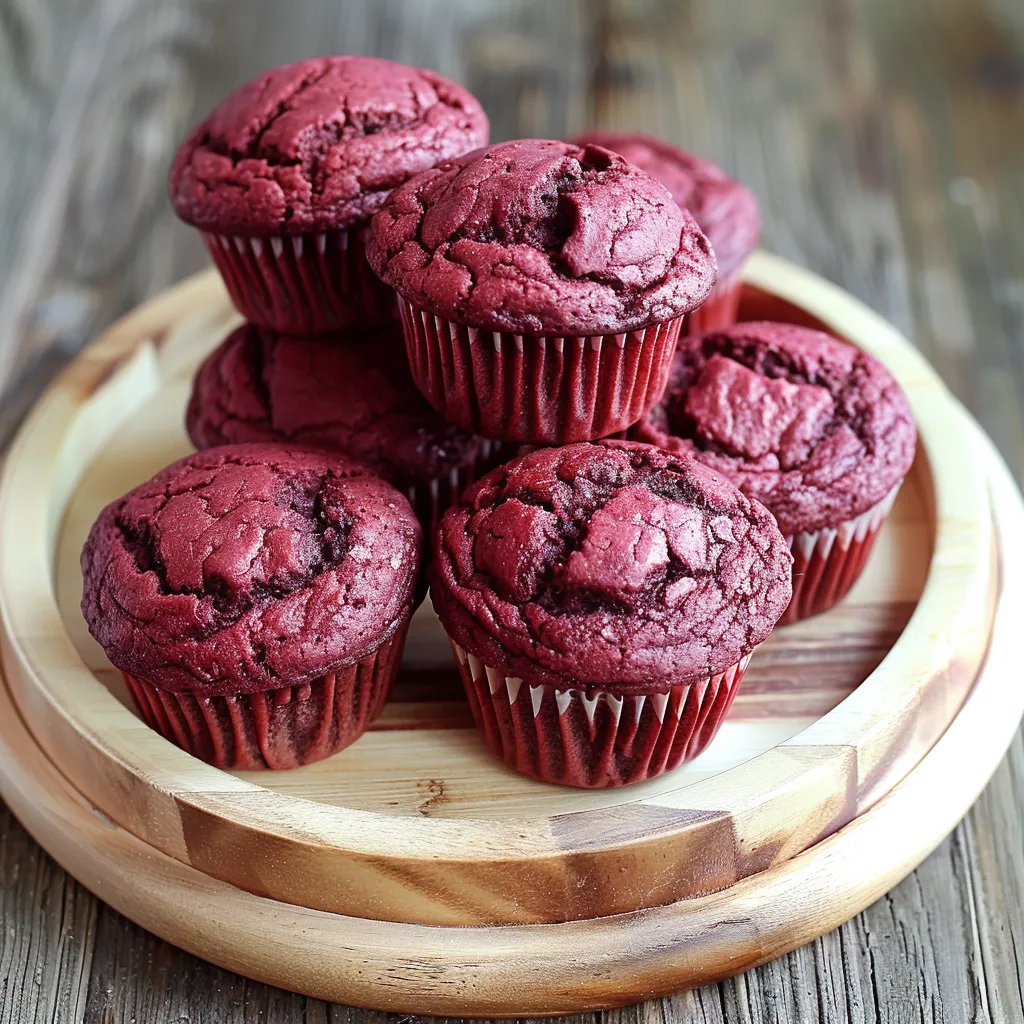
[{"xmin": 77, "ymin": 57, "xmax": 914, "ymax": 786}]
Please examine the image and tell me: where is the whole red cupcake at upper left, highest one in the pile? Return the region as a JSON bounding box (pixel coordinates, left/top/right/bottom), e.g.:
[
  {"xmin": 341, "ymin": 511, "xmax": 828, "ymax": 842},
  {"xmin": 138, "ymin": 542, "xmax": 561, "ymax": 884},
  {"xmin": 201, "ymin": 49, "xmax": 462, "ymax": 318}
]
[{"xmin": 170, "ymin": 56, "xmax": 487, "ymax": 334}]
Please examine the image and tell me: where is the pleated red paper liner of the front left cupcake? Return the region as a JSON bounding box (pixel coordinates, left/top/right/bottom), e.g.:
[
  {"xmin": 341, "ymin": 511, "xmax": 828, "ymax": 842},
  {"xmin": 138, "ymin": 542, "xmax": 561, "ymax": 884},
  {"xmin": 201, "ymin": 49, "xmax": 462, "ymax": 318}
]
[{"xmin": 122, "ymin": 622, "xmax": 409, "ymax": 770}]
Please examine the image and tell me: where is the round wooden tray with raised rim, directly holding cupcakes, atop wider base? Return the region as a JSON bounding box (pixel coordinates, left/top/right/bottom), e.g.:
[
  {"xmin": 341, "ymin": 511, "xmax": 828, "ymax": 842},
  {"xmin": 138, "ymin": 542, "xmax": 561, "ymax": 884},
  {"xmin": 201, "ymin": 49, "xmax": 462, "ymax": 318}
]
[{"xmin": 0, "ymin": 255, "xmax": 997, "ymax": 926}]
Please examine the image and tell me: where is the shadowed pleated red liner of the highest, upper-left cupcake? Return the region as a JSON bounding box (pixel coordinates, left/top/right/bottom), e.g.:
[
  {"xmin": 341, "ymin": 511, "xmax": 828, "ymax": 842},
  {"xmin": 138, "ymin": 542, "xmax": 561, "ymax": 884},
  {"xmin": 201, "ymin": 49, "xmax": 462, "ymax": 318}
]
[{"xmin": 203, "ymin": 228, "xmax": 395, "ymax": 334}]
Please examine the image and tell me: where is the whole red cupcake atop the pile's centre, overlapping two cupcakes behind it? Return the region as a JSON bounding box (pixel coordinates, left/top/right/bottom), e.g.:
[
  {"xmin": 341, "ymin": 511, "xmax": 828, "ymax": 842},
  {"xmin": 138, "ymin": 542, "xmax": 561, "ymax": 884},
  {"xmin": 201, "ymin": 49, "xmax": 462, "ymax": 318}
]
[{"xmin": 367, "ymin": 139, "xmax": 715, "ymax": 444}]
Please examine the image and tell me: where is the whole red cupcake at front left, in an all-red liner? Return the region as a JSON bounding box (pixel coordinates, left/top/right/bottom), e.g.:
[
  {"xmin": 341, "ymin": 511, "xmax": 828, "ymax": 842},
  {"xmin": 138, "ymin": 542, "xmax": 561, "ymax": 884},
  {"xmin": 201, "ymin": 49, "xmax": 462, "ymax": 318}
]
[{"xmin": 82, "ymin": 444, "xmax": 422, "ymax": 769}]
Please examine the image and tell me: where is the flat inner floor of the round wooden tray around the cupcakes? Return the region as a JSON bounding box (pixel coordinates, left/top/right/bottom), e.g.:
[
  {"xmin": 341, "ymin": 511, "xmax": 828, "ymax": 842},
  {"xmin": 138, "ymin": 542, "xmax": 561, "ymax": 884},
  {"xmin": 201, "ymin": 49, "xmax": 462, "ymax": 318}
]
[{"xmin": 54, "ymin": 405, "xmax": 932, "ymax": 819}]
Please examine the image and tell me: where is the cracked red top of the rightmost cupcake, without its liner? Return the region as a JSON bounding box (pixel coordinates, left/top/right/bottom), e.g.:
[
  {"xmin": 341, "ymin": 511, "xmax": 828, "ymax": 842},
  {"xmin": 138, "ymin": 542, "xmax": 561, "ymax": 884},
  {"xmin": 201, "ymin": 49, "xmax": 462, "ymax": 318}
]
[{"xmin": 630, "ymin": 323, "xmax": 918, "ymax": 535}]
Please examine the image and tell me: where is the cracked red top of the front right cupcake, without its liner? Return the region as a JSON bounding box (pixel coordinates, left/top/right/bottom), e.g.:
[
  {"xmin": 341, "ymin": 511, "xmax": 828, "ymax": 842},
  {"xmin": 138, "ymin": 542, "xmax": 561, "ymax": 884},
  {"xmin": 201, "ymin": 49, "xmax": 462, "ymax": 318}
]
[{"xmin": 431, "ymin": 441, "xmax": 793, "ymax": 694}]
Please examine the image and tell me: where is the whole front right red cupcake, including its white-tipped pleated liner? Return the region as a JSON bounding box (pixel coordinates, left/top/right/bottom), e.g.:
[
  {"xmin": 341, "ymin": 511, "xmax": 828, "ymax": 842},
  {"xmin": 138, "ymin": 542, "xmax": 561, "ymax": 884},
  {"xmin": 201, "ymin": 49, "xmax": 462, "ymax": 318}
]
[{"xmin": 431, "ymin": 441, "xmax": 793, "ymax": 787}]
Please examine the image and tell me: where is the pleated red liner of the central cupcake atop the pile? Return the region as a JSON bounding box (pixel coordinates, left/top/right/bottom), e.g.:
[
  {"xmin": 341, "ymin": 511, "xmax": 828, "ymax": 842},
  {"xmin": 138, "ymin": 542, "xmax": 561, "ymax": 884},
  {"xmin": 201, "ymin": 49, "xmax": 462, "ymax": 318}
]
[{"xmin": 398, "ymin": 296, "xmax": 682, "ymax": 444}]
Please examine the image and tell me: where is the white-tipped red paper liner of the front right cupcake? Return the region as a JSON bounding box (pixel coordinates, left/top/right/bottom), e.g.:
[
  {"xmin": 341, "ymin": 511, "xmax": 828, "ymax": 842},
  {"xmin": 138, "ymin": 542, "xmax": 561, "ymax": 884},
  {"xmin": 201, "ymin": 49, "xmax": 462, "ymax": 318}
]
[{"xmin": 452, "ymin": 641, "xmax": 750, "ymax": 788}]
